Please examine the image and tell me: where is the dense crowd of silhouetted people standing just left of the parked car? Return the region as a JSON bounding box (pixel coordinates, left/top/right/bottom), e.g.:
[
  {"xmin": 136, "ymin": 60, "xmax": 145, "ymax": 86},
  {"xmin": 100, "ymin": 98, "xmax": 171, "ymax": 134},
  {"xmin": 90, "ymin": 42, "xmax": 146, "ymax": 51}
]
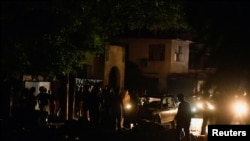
[{"xmin": 75, "ymin": 85, "xmax": 140, "ymax": 130}]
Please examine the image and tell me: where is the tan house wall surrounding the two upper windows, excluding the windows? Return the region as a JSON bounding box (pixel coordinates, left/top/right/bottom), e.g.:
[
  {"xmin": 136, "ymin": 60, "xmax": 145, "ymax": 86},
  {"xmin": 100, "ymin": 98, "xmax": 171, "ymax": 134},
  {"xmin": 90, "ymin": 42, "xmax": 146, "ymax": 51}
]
[{"xmin": 116, "ymin": 38, "xmax": 190, "ymax": 90}]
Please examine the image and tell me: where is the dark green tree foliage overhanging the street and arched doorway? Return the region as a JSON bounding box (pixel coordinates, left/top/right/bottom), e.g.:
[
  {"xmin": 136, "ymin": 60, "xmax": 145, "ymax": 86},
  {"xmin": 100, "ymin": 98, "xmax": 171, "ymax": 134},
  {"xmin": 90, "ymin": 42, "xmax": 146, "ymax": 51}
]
[{"xmin": 1, "ymin": 0, "xmax": 189, "ymax": 79}]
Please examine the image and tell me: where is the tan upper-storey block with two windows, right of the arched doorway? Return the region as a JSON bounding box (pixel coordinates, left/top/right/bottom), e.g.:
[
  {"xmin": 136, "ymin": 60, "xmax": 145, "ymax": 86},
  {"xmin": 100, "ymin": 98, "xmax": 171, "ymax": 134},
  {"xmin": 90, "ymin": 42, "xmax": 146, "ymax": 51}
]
[{"xmin": 119, "ymin": 38, "xmax": 191, "ymax": 91}]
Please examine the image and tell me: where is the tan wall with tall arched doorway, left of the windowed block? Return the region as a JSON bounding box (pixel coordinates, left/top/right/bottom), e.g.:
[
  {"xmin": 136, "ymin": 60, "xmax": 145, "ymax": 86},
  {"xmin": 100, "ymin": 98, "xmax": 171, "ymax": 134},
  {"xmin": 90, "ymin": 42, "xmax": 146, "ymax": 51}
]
[{"xmin": 84, "ymin": 44, "xmax": 125, "ymax": 88}]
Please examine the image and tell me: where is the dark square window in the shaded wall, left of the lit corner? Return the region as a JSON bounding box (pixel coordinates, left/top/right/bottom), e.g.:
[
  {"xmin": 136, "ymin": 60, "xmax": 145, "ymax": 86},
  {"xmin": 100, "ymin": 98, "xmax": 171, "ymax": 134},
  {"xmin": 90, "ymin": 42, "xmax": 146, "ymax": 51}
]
[{"xmin": 148, "ymin": 44, "xmax": 165, "ymax": 61}]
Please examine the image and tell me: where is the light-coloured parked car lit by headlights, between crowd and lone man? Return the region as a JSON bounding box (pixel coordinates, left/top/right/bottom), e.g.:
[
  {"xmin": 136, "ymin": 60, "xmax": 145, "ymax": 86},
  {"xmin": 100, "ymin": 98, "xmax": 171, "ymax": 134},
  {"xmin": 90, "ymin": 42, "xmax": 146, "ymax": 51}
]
[{"xmin": 137, "ymin": 95, "xmax": 179, "ymax": 127}]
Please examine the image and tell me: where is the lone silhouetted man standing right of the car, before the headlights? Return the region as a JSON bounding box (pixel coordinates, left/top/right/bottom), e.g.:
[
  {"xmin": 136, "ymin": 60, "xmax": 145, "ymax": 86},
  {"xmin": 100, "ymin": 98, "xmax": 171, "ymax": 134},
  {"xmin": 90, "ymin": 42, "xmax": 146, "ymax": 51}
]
[{"xmin": 175, "ymin": 93, "xmax": 192, "ymax": 141}]
